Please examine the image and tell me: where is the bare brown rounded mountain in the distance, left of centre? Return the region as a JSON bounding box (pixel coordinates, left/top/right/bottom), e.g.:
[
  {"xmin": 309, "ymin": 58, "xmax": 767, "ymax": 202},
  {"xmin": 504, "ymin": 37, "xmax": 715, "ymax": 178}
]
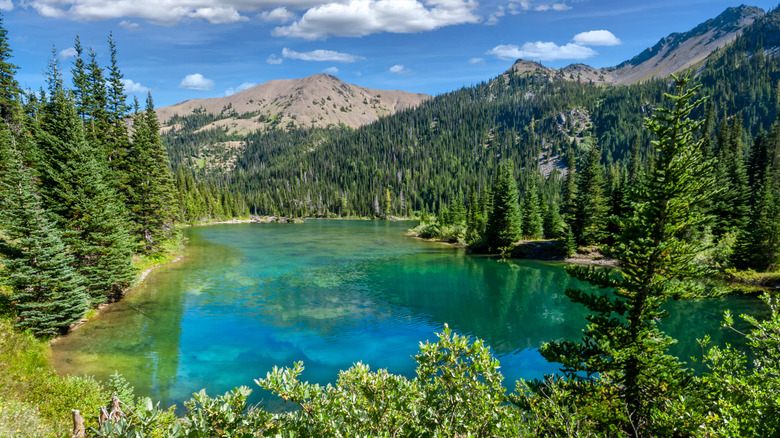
[{"xmin": 157, "ymin": 74, "xmax": 430, "ymax": 134}]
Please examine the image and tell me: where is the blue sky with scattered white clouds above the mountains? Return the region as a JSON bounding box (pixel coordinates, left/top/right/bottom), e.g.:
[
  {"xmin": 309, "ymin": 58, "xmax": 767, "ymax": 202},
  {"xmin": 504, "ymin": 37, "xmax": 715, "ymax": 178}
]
[{"xmin": 0, "ymin": 0, "xmax": 778, "ymax": 107}]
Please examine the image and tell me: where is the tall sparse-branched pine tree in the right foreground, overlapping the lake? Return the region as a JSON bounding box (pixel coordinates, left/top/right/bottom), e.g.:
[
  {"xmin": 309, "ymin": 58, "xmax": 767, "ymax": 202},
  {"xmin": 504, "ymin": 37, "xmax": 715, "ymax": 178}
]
[{"xmin": 541, "ymin": 78, "xmax": 712, "ymax": 436}]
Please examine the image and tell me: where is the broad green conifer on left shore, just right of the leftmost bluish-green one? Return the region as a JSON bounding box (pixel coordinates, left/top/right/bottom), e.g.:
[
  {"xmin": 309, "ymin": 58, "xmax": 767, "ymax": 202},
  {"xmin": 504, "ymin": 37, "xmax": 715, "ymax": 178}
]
[{"xmin": 35, "ymin": 90, "xmax": 135, "ymax": 302}]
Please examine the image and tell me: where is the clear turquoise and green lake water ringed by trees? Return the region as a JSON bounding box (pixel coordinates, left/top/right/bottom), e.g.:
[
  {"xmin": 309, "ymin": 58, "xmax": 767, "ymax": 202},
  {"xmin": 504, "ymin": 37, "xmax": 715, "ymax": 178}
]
[{"xmin": 52, "ymin": 220, "xmax": 762, "ymax": 409}]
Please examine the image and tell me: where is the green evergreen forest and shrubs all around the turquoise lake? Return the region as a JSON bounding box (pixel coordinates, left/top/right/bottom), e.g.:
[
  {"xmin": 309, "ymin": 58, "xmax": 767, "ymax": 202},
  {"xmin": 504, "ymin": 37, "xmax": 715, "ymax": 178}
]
[{"xmin": 0, "ymin": 6, "xmax": 780, "ymax": 437}]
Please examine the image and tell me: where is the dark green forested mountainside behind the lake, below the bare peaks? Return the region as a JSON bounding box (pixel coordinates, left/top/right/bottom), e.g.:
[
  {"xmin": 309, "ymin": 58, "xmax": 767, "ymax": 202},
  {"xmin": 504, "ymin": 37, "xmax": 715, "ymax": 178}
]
[{"xmin": 169, "ymin": 4, "xmax": 780, "ymax": 220}]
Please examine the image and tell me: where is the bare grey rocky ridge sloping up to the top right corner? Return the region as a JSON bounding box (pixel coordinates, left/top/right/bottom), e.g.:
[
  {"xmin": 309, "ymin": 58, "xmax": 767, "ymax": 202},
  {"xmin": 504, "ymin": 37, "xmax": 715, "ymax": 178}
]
[{"xmin": 507, "ymin": 5, "xmax": 765, "ymax": 85}]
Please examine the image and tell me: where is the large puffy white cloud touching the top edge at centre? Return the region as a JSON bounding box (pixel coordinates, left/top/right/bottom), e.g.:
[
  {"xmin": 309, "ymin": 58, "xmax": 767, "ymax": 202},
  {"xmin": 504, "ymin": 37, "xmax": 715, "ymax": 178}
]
[{"xmin": 273, "ymin": 0, "xmax": 481, "ymax": 40}]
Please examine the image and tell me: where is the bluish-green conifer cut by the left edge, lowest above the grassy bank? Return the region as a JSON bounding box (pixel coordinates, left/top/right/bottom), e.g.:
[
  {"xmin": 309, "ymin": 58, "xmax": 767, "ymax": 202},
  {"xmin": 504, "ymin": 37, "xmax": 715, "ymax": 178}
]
[{"xmin": 0, "ymin": 123, "xmax": 87, "ymax": 336}]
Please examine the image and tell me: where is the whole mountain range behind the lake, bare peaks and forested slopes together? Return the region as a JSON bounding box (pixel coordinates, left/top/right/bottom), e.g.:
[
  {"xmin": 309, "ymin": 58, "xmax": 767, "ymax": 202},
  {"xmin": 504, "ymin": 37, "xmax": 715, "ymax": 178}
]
[{"xmin": 165, "ymin": 6, "xmax": 780, "ymax": 221}]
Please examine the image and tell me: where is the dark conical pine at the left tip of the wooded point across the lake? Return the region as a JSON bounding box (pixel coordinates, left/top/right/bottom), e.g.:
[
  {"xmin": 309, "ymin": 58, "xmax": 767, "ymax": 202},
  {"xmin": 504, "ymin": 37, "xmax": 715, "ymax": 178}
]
[{"xmin": 485, "ymin": 162, "xmax": 522, "ymax": 251}]
